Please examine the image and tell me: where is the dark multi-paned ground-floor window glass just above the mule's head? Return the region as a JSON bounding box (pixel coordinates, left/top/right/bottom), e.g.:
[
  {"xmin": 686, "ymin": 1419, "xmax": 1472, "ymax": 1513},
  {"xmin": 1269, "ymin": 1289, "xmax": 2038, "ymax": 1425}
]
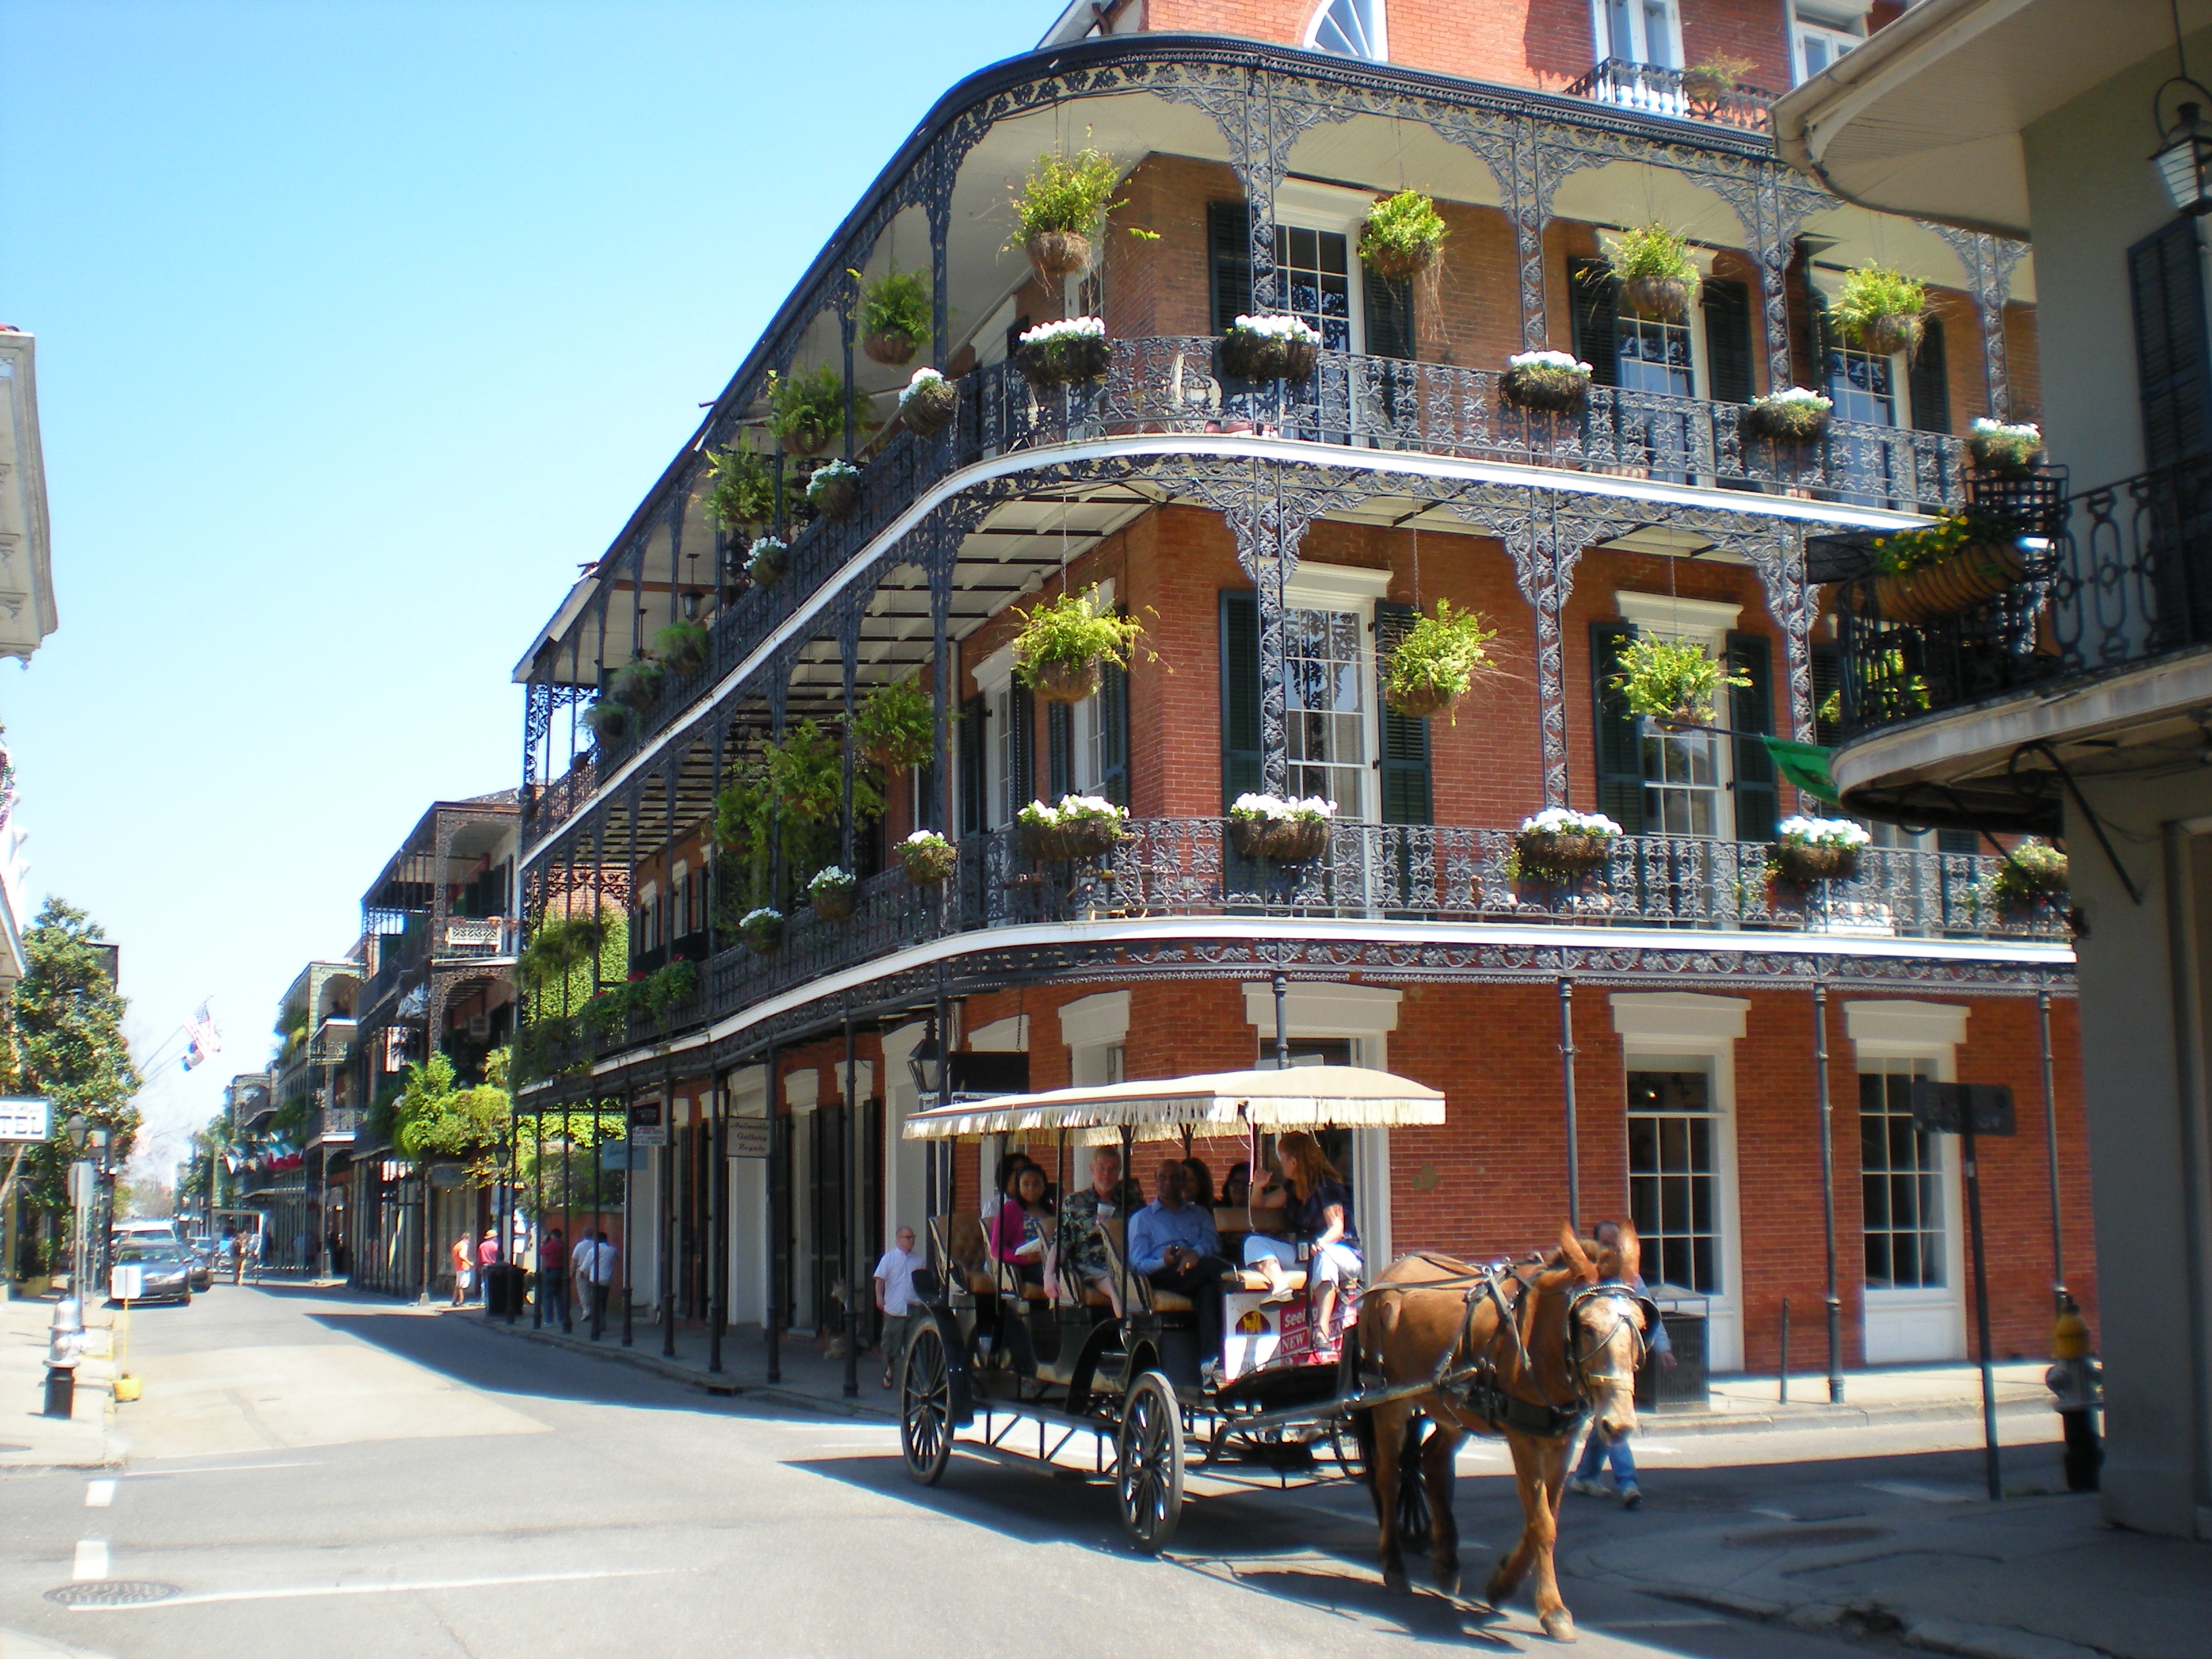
[{"xmin": 1628, "ymin": 1071, "xmax": 1723, "ymax": 1296}]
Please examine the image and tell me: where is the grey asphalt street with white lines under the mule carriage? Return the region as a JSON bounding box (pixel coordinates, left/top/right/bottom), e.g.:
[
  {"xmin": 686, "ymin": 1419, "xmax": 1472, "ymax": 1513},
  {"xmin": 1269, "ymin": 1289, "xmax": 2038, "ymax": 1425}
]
[{"xmin": 0, "ymin": 1285, "xmax": 2060, "ymax": 1659}]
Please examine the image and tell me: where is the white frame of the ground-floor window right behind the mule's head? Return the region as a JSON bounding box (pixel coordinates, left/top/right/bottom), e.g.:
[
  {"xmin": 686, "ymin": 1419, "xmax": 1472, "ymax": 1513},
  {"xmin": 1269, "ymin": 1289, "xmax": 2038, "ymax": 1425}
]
[{"xmin": 1610, "ymin": 991, "xmax": 1752, "ymax": 1372}]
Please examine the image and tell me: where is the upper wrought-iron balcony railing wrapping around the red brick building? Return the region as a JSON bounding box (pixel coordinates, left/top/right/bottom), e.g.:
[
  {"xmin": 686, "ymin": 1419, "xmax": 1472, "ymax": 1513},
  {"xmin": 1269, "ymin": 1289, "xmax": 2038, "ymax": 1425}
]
[{"xmin": 539, "ymin": 334, "xmax": 1964, "ymax": 840}]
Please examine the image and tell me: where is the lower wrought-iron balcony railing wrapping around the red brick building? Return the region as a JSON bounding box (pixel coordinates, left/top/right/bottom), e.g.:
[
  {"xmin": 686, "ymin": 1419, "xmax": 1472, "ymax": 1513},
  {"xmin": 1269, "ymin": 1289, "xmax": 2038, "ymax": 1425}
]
[{"xmin": 522, "ymin": 819, "xmax": 2066, "ymax": 1075}]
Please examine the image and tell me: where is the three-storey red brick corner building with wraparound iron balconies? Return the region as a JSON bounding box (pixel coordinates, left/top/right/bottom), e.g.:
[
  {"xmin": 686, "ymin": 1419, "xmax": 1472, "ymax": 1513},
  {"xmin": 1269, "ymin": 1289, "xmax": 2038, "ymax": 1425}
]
[{"xmin": 518, "ymin": 0, "xmax": 2095, "ymax": 1369}]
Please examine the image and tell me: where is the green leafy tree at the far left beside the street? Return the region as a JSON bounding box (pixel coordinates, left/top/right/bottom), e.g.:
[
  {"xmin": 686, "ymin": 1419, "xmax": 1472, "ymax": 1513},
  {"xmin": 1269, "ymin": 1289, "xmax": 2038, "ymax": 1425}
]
[{"xmin": 14, "ymin": 898, "xmax": 140, "ymax": 1210}]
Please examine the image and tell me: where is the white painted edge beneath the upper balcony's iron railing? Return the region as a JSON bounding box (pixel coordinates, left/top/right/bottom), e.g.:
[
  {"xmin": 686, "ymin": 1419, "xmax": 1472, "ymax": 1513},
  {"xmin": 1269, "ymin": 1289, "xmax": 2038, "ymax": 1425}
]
[{"xmin": 520, "ymin": 434, "xmax": 1927, "ymax": 867}]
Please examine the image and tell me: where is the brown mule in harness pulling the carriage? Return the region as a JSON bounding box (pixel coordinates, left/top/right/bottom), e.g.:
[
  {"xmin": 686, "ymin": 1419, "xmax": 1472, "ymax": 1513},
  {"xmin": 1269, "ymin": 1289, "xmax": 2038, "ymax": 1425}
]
[{"xmin": 1358, "ymin": 1223, "xmax": 1650, "ymax": 1641}]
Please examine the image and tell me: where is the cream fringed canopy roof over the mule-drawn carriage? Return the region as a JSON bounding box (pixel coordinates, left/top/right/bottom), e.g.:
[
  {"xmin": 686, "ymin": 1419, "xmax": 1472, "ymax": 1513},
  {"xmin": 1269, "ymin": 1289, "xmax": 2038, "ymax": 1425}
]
[{"xmin": 905, "ymin": 1066, "xmax": 1444, "ymax": 1141}]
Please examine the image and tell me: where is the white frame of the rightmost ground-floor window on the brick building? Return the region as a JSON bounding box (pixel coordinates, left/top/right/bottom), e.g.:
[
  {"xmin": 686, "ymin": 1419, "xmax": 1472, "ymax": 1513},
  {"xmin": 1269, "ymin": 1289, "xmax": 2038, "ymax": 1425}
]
[{"xmin": 1843, "ymin": 998, "xmax": 1971, "ymax": 1365}]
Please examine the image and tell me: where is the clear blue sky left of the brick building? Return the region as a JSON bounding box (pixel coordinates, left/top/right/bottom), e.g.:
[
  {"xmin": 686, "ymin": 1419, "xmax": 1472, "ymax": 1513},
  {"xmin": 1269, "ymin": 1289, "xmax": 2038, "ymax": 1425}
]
[{"xmin": 0, "ymin": 0, "xmax": 1059, "ymax": 1185}]
